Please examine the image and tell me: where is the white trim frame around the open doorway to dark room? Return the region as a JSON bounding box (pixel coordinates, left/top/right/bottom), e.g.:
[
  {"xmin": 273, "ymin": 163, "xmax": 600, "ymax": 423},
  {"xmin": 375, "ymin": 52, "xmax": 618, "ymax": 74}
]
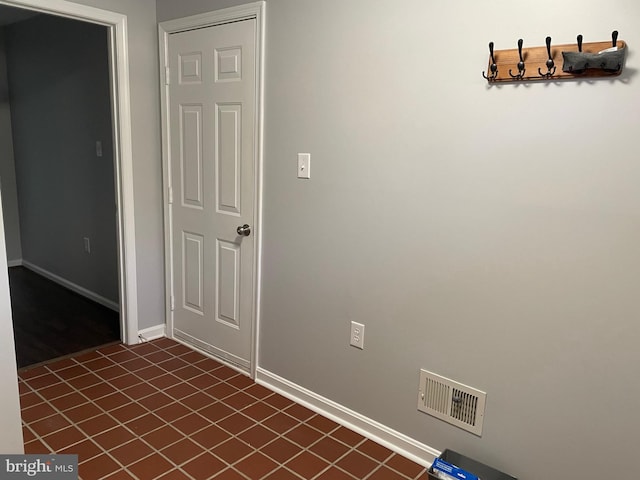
[{"xmin": 0, "ymin": 0, "xmax": 138, "ymax": 345}]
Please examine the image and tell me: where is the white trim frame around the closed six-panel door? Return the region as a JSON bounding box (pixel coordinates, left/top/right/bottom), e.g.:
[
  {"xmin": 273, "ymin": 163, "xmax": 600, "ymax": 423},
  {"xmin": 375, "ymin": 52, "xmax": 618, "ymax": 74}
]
[{"xmin": 158, "ymin": 1, "xmax": 265, "ymax": 378}]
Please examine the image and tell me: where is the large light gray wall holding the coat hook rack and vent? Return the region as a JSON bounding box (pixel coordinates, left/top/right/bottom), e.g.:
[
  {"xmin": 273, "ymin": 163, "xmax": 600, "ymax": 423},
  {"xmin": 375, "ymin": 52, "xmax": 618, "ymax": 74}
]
[{"xmin": 158, "ymin": 0, "xmax": 640, "ymax": 479}]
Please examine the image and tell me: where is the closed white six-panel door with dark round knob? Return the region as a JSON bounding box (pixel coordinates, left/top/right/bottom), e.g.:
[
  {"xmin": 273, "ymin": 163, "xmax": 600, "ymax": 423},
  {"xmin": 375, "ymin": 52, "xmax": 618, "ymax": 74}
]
[{"xmin": 168, "ymin": 20, "xmax": 256, "ymax": 370}]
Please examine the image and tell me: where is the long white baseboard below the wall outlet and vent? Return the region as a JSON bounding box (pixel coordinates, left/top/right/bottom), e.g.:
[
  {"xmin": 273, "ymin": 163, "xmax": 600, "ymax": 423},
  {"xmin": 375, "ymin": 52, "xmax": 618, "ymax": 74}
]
[{"xmin": 256, "ymin": 367, "xmax": 440, "ymax": 467}]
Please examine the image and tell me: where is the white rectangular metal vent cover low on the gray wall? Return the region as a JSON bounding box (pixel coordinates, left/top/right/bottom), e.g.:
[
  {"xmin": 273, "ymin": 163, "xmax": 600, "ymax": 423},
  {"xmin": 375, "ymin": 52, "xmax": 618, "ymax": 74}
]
[{"xmin": 418, "ymin": 370, "xmax": 487, "ymax": 436}]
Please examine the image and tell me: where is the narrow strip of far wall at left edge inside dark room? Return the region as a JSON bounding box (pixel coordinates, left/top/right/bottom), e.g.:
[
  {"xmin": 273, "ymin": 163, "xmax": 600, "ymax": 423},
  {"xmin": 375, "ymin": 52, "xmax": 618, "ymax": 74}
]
[{"xmin": 0, "ymin": 27, "xmax": 22, "ymax": 261}]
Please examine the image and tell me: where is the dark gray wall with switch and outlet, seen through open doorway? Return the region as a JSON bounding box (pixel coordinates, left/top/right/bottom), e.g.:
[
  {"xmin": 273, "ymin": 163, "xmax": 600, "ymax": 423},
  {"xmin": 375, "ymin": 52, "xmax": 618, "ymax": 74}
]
[{"xmin": 6, "ymin": 15, "xmax": 118, "ymax": 302}]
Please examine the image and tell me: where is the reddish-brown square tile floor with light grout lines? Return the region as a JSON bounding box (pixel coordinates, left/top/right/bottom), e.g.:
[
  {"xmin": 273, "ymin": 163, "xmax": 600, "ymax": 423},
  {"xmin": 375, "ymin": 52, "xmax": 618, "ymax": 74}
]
[{"xmin": 18, "ymin": 338, "xmax": 427, "ymax": 480}]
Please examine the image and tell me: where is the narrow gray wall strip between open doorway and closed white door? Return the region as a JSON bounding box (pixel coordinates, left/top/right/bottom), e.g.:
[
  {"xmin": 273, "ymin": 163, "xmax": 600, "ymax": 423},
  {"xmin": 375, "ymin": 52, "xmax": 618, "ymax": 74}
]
[{"xmin": 74, "ymin": 0, "xmax": 164, "ymax": 330}]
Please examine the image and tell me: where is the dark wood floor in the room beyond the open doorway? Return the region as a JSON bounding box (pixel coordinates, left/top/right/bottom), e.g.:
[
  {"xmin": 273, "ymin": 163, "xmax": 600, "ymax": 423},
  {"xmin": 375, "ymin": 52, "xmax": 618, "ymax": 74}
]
[{"xmin": 9, "ymin": 267, "xmax": 120, "ymax": 368}]
